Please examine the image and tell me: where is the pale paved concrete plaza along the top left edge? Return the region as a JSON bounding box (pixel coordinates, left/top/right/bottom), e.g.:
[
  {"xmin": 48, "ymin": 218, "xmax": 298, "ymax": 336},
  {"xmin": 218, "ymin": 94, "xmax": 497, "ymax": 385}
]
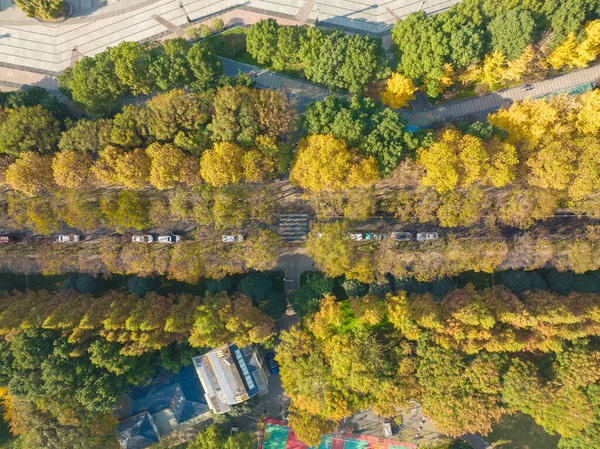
[{"xmin": 0, "ymin": 0, "xmax": 458, "ymax": 75}]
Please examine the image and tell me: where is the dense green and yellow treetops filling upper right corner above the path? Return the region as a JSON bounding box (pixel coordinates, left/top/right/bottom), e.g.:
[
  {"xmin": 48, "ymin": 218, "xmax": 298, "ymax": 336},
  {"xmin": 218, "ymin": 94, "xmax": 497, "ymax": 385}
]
[{"xmin": 392, "ymin": 0, "xmax": 600, "ymax": 97}]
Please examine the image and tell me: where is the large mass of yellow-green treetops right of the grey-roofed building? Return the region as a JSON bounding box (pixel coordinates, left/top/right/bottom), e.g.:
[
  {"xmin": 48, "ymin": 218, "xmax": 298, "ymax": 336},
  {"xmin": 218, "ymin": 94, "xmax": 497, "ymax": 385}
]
[{"xmin": 278, "ymin": 285, "xmax": 600, "ymax": 448}]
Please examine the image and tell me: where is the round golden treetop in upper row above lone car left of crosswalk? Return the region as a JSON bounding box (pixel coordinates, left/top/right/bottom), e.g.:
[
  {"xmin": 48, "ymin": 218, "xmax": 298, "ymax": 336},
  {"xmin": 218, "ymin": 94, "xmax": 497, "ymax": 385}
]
[{"xmin": 200, "ymin": 142, "xmax": 244, "ymax": 187}]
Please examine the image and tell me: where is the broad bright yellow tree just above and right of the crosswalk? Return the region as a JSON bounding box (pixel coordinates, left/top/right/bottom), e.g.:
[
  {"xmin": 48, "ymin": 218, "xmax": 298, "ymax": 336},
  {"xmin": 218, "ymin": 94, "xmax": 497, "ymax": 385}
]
[{"xmin": 290, "ymin": 134, "xmax": 379, "ymax": 192}]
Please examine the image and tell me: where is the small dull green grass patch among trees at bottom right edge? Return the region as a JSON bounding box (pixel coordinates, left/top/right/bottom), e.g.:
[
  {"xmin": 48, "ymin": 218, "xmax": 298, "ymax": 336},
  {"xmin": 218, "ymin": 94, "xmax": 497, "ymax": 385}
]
[{"xmin": 486, "ymin": 414, "xmax": 560, "ymax": 449}]
